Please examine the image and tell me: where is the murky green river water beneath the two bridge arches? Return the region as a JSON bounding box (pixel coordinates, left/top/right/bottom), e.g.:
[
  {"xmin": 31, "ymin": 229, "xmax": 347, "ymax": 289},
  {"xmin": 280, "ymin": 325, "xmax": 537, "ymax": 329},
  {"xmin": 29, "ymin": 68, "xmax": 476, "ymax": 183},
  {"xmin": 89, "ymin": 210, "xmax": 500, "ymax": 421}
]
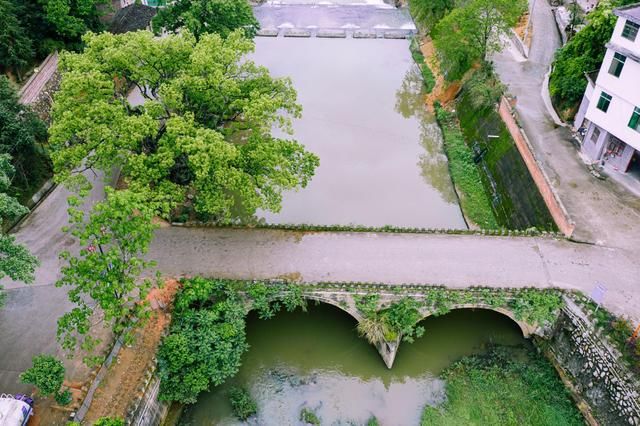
[{"xmin": 179, "ymin": 305, "xmax": 527, "ymax": 426}]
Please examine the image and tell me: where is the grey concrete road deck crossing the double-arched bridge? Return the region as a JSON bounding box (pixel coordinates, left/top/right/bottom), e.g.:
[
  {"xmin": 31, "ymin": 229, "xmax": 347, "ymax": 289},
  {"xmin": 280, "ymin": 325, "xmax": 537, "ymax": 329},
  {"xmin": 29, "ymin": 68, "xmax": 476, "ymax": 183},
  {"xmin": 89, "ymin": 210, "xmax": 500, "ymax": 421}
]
[{"xmin": 149, "ymin": 227, "xmax": 640, "ymax": 317}]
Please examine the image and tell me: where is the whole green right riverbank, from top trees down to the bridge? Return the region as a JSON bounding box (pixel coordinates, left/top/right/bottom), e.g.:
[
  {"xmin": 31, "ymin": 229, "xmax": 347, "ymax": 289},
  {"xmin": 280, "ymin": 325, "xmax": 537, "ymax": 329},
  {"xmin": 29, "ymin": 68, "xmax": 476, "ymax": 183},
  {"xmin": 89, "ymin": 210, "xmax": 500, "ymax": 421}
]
[{"xmin": 410, "ymin": 0, "xmax": 556, "ymax": 231}]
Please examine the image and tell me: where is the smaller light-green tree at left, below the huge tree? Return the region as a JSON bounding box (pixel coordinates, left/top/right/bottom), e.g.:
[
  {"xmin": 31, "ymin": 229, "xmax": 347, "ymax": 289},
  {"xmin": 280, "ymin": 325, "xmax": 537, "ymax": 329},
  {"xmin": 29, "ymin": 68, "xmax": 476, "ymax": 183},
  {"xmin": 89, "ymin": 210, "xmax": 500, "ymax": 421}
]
[{"xmin": 56, "ymin": 188, "xmax": 155, "ymax": 359}]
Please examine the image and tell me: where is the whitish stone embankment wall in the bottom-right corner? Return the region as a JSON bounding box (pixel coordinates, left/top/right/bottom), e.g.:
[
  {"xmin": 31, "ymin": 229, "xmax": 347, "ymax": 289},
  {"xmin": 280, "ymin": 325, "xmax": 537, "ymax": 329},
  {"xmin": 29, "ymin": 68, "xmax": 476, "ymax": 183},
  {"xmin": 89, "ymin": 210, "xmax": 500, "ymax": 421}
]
[{"xmin": 545, "ymin": 301, "xmax": 640, "ymax": 425}]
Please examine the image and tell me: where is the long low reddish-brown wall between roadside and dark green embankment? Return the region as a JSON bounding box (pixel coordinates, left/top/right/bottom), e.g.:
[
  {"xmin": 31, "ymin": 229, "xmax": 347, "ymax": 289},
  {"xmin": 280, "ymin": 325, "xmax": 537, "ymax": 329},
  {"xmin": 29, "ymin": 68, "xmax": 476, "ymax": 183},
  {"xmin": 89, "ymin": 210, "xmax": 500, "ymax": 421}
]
[{"xmin": 498, "ymin": 97, "xmax": 575, "ymax": 237}]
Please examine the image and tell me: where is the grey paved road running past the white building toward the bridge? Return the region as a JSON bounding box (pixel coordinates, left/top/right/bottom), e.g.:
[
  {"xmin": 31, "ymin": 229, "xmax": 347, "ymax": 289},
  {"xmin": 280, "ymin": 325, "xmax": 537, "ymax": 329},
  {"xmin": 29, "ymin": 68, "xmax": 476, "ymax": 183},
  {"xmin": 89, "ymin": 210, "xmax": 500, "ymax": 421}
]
[{"xmin": 494, "ymin": 0, "xmax": 640, "ymax": 250}]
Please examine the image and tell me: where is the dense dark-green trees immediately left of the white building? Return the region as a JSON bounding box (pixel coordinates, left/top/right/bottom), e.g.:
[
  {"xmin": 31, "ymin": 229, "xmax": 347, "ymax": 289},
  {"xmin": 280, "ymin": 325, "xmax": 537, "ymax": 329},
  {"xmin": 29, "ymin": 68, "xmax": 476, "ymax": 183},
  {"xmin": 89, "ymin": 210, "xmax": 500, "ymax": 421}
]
[{"xmin": 549, "ymin": 0, "xmax": 636, "ymax": 120}]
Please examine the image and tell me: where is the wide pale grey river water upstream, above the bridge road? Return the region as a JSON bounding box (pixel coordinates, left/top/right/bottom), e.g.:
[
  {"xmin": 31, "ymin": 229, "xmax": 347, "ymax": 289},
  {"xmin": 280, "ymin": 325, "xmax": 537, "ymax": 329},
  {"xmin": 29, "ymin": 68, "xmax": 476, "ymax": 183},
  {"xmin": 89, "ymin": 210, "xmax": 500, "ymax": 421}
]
[{"xmin": 252, "ymin": 37, "xmax": 466, "ymax": 228}]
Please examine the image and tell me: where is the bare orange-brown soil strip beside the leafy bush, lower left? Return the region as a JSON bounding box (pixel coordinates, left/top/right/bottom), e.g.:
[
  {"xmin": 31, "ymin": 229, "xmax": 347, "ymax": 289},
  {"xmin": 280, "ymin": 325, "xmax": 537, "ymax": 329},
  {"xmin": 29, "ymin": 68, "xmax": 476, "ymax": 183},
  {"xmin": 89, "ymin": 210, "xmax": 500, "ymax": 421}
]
[{"xmin": 85, "ymin": 280, "xmax": 180, "ymax": 424}]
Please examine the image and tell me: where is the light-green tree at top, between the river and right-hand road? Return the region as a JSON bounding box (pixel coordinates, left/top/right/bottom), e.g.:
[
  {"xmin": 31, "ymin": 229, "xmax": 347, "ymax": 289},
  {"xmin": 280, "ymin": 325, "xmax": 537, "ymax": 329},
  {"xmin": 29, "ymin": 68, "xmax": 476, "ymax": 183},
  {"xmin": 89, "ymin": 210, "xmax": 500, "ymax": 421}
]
[{"xmin": 433, "ymin": 0, "xmax": 526, "ymax": 80}]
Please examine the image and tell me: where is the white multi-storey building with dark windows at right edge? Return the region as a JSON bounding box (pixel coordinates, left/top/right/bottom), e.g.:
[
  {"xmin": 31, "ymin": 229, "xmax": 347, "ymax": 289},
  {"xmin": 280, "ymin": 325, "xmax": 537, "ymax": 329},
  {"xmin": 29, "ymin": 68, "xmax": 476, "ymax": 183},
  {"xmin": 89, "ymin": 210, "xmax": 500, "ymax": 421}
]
[{"xmin": 575, "ymin": 3, "xmax": 640, "ymax": 172}]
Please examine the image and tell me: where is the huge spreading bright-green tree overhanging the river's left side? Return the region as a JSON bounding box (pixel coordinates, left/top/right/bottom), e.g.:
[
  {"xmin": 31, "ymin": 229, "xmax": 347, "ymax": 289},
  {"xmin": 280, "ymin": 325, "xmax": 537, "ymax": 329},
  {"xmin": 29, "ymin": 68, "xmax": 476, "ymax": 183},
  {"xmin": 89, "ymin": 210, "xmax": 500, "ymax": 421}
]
[{"xmin": 50, "ymin": 31, "xmax": 319, "ymax": 221}]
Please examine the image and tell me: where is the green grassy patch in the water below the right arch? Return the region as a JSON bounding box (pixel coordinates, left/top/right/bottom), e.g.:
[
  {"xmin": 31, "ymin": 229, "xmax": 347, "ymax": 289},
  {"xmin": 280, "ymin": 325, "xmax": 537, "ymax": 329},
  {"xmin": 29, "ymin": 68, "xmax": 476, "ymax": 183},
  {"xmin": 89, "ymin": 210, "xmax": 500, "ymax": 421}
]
[{"xmin": 420, "ymin": 347, "xmax": 584, "ymax": 426}]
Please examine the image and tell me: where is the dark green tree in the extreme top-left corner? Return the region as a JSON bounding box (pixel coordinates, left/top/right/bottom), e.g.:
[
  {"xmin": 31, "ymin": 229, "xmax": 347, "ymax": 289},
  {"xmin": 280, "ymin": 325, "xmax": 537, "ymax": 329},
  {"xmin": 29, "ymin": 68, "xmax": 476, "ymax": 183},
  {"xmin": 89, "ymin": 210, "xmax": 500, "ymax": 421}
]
[{"xmin": 0, "ymin": 0, "xmax": 34, "ymax": 79}]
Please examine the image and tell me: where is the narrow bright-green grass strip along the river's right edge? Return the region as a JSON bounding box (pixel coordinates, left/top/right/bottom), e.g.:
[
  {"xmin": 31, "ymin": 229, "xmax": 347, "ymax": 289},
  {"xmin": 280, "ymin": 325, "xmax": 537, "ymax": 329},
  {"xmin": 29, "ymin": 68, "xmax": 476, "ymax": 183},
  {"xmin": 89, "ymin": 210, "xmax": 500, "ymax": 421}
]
[{"xmin": 435, "ymin": 105, "xmax": 499, "ymax": 229}]
